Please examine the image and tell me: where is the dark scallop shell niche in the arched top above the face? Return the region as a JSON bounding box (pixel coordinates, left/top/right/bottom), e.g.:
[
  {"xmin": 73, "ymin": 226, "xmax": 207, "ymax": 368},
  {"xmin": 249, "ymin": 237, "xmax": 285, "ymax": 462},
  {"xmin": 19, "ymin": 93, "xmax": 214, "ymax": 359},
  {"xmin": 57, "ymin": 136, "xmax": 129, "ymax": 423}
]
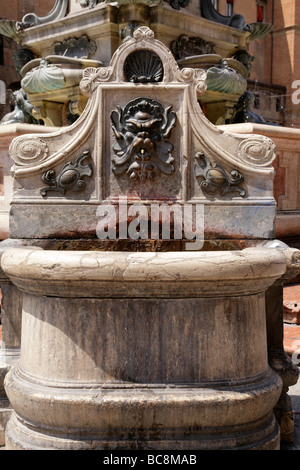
[{"xmin": 124, "ymin": 50, "xmax": 164, "ymax": 83}]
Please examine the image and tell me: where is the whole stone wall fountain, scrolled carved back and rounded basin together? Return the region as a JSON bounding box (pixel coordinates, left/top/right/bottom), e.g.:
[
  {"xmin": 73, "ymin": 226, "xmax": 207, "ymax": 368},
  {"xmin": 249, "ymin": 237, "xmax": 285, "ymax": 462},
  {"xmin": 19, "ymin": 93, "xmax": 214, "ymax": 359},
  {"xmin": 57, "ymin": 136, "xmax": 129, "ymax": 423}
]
[{"xmin": 1, "ymin": 26, "xmax": 300, "ymax": 450}]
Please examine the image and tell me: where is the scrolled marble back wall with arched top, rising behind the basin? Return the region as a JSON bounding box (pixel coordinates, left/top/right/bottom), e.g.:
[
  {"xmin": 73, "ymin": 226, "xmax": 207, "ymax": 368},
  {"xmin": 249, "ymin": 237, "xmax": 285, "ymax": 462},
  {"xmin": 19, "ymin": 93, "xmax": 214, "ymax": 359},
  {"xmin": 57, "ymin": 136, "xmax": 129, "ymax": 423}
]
[{"xmin": 10, "ymin": 27, "xmax": 276, "ymax": 238}]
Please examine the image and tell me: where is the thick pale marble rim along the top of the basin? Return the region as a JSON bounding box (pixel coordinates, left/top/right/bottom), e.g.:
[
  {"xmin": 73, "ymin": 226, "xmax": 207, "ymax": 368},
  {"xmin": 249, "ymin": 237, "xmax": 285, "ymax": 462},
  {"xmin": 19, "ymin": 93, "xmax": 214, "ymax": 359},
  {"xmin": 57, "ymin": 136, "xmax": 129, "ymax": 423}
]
[{"xmin": 1, "ymin": 247, "xmax": 287, "ymax": 298}]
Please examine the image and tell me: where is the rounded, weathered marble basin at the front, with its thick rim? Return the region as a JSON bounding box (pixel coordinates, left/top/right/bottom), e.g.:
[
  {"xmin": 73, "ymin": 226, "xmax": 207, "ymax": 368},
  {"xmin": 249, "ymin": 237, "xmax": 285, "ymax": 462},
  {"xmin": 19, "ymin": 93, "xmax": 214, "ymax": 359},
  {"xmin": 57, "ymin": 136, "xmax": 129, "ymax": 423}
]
[{"xmin": 1, "ymin": 247, "xmax": 286, "ymax": 450}]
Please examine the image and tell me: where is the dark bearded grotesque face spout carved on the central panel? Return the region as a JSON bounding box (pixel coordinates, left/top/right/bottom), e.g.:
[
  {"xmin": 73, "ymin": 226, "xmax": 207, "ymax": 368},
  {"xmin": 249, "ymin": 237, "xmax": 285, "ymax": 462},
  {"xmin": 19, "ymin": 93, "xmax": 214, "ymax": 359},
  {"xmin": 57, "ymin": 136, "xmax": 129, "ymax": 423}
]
[{"xmin": 111, "ymin": 98, "xmax": 176, "ymax": 182}]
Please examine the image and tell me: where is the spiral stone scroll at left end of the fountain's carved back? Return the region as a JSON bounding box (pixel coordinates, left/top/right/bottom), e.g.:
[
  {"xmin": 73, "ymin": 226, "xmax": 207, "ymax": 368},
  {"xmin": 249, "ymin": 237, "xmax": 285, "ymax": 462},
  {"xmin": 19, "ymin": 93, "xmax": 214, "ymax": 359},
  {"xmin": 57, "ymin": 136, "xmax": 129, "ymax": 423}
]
[{"xmin": 9, "ymin": 136, "xmax": 49, "ymax": 166}]
